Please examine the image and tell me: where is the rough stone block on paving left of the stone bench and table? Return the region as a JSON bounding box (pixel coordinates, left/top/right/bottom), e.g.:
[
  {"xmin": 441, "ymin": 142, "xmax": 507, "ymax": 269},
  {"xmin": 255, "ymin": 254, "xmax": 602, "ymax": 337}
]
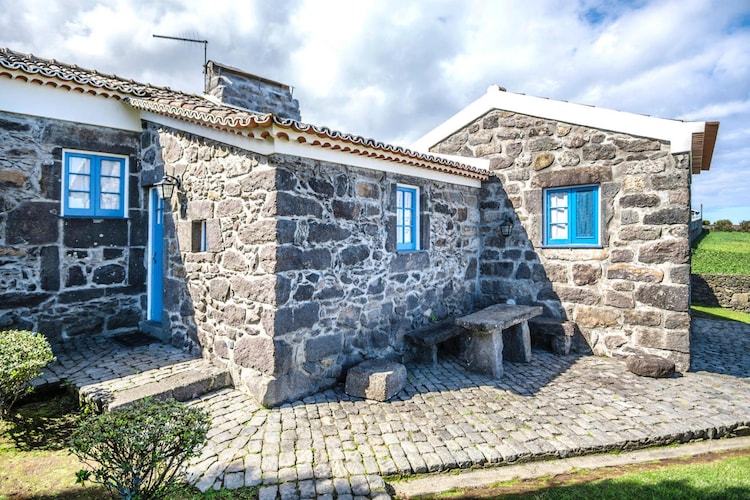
[{"xmin": 345, "ymin": 359, "xmax": 406, "ymax": 401}]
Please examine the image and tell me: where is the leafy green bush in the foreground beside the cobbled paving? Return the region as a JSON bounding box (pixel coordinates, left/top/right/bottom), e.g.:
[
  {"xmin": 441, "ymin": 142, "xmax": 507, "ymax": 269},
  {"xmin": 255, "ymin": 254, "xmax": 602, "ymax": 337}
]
[{"xmin": 70, "ymin": 398, "xmax": 211, "ymax": 500}]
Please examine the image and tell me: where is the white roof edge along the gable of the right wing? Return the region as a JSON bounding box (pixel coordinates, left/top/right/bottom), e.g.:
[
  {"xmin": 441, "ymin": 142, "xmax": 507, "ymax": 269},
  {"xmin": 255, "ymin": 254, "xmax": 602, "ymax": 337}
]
[{"xmin": 411, "ymin": 85, "xmax": 706, "ymax": 153}]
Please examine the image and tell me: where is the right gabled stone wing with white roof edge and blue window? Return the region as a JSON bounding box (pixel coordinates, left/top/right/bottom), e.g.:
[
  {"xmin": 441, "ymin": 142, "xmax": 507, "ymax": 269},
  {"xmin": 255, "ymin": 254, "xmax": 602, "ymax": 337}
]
[{"xmin": 414, "ymin": 86, "xmax": 719, "ymax": 371}]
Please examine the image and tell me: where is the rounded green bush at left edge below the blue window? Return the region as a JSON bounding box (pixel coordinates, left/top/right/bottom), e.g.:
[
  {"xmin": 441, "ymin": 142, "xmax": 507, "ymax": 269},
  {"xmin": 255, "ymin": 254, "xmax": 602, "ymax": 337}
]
[{"xmin": 0, "ymin": 330, "xmax": 55, "ymax": 418}]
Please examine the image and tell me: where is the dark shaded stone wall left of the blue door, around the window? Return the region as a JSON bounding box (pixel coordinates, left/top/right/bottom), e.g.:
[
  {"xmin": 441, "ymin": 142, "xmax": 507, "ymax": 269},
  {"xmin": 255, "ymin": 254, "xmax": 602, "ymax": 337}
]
[{"xmin": 0, "ymin": 113, "xmax": 147, "ymax": 341}]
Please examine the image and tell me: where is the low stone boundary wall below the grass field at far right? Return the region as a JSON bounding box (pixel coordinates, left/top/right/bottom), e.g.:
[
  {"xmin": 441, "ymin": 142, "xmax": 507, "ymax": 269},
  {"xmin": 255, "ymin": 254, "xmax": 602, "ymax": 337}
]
[{"xmin": 690, "ymin": 274, "xmax": 750, "ymax": 313}]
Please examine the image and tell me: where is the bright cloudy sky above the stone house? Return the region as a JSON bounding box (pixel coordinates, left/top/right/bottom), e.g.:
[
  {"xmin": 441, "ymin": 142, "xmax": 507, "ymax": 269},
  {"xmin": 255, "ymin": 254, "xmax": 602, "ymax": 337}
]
[{"xmin": 0, "ymin": 0, "xmax": 750, "ymax": 224}]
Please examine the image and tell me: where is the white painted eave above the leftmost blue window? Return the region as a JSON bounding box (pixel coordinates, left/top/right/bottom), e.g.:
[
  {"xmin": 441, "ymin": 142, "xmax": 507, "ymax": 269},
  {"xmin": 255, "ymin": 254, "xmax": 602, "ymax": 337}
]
[{"xmin": 0, "ymin": 77, "xmax": 141, "ymax": 132}]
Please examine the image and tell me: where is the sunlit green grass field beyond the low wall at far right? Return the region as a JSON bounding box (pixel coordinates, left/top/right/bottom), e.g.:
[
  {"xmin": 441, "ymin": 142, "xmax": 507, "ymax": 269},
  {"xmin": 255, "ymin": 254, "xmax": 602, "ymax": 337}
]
[{"xmin": 692, "ymin": 231, "xmax": 750, "ymax": 274}]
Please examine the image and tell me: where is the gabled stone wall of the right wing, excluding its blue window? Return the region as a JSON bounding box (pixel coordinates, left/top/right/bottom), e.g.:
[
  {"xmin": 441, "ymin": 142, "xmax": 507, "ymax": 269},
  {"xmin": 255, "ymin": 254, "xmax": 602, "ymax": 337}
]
[{"xmin": 434, "ymin": 110, "xmax": 690, "ymax": 370}]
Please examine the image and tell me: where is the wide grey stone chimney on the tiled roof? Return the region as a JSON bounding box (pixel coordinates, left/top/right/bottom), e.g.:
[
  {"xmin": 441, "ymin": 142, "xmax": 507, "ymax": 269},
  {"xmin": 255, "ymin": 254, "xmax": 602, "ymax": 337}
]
[{"xmin": 206, "ymin": 61, "xmax": 302, "ymax": 121}]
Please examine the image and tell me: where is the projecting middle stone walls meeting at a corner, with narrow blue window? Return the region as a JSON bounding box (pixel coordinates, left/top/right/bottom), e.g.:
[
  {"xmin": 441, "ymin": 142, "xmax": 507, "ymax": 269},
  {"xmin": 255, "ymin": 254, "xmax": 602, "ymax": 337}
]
[{"xmin": 148, "ymin": 124, "xmax": 479, "ymax": 405}]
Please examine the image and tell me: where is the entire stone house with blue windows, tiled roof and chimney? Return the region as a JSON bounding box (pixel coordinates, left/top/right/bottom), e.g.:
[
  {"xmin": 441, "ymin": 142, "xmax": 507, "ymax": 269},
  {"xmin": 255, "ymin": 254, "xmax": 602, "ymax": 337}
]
[{"xmin": 0, "ymin": 49, "xmax": 717, "ymax": 405}]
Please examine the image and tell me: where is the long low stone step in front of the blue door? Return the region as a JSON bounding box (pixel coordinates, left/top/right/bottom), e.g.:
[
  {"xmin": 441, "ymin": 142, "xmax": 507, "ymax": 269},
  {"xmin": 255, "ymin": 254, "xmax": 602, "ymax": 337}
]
[{"xmin": 78, "ymin": 359, "xmax": 232, "ymax": 412}]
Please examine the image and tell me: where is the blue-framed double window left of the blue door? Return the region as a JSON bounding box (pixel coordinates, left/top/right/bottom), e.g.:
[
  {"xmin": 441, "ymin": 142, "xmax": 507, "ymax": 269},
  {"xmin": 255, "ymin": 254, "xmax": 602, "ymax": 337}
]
[{"xmin": 63, "ymin": 151, "xmax": 127, "ymax": 218}]
